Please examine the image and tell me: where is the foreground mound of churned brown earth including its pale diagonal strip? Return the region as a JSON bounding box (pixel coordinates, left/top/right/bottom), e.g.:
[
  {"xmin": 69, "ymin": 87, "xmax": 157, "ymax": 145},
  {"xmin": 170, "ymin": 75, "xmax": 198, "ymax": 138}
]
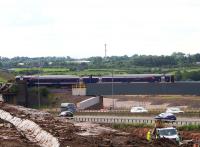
[{"xmin": 0, "ymin": 103, "xmax": 200, "ymax": 147}]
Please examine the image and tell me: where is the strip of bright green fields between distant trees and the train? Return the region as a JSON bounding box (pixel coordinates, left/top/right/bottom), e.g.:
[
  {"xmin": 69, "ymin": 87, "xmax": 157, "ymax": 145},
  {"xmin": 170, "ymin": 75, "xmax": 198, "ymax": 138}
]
[{"xmin": 12, "ymin": 66, "xmax": 200, "ymax": 79}]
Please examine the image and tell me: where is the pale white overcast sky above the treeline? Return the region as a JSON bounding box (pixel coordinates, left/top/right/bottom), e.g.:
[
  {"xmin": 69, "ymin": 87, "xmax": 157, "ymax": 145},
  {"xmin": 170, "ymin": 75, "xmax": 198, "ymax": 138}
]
[{"xmin": 0, "ymin": 0, "xmax": 200, "ymax": 58}]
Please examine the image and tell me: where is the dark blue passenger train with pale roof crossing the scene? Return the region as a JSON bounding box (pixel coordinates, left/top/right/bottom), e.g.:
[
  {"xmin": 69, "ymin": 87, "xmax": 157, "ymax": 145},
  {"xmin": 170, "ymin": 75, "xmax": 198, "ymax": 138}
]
[{"xmin": 15, "ymin": 74, "xmax": 174, "ymax": 86}]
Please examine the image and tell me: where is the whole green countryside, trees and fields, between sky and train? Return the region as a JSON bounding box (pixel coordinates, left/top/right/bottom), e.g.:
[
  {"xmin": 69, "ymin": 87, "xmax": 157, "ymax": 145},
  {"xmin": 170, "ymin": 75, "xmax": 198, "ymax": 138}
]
[{"xmin": 0, "ymin": 52, "xmax": 200, "ymax": 81}]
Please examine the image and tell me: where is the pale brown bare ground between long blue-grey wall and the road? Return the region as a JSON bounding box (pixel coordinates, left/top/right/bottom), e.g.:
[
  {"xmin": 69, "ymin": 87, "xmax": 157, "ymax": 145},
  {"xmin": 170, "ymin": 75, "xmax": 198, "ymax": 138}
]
[{"xmin": 104, "ymin": 95, "xmax": 200, "ymax": 109}]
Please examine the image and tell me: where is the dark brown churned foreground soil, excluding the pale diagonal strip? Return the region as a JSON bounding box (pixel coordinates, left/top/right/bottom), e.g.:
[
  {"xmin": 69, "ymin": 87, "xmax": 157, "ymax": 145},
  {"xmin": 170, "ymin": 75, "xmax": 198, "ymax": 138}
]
[{"xmin": 0, "ymin": 104, "xmax": 200, "ymax": 147}]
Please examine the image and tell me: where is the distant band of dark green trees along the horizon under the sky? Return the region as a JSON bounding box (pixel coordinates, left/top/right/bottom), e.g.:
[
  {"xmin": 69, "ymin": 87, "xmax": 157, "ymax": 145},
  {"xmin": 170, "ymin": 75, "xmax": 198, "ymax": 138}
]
[{"xmin": 0, "ymin": 52, "xmax": 200, "ymax": 69}]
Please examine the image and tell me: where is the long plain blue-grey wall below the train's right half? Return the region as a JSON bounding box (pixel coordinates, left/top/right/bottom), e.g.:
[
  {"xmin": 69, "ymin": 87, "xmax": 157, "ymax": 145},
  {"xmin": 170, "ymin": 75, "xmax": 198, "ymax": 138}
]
[{"xmin": 86, "ymin": 82, "xmax": 200, "ymax": 95}]
